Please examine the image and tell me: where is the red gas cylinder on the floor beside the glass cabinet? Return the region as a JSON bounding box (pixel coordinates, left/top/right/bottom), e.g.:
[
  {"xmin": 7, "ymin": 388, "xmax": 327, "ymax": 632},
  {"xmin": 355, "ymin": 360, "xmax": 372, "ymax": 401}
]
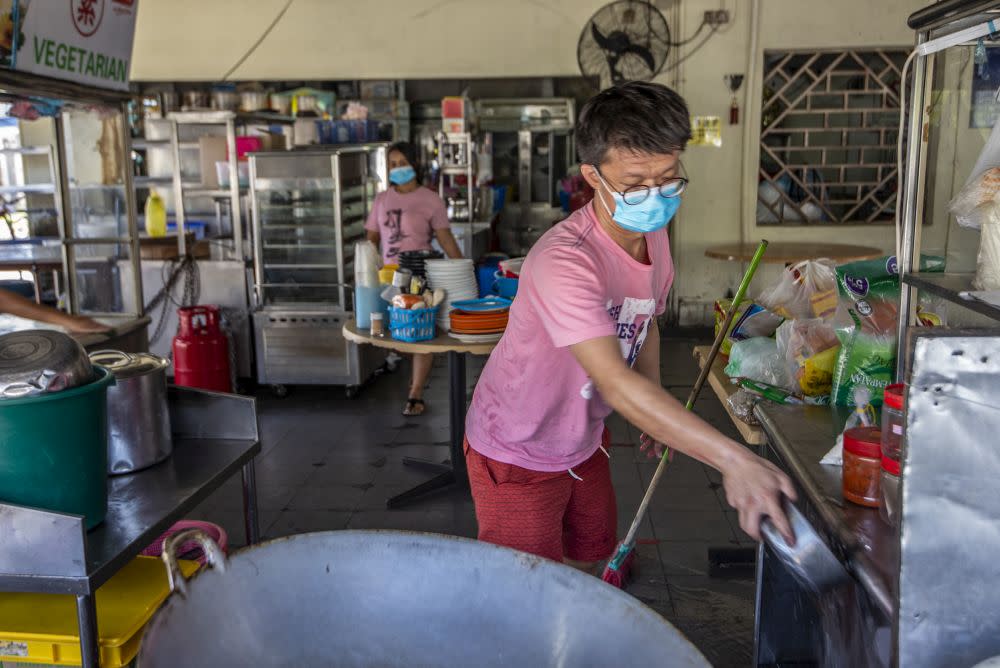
[{"xmin": 173, "ymin": 306, "xmax": 233, "ymax": 392}]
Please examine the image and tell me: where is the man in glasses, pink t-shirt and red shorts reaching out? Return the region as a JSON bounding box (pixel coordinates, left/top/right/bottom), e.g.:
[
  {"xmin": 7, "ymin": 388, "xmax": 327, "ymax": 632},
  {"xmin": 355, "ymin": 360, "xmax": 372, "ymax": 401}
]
[{"xmin": 465, "ymin": 82, "xmax": 795, "ymax": 572}]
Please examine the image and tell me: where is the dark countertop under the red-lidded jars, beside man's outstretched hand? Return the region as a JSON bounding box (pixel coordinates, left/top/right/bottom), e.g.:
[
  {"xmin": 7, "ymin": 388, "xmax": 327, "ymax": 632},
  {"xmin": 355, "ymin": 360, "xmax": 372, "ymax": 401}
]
[{"xmin": 755, "ymin": 402, "xmax": 899, "ymax": 618}]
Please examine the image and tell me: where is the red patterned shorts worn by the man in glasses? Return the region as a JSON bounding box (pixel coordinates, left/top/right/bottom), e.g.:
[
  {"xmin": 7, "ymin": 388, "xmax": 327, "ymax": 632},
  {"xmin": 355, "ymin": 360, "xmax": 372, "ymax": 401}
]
[{"xmin": 465, "ymin": 432, "xmax": 618, "ymax": 562}]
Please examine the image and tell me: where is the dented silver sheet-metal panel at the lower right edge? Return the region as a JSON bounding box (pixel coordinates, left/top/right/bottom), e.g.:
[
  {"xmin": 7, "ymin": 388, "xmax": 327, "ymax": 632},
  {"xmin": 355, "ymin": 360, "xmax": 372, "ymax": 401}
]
[{"xmin": 897, "ymin": 330, "xmax": 1000, "ymax": 668}]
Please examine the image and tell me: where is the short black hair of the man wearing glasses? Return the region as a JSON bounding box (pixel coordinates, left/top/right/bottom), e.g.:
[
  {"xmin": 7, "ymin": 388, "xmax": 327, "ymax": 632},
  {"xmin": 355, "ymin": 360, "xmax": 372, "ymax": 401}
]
[{"xmin": 576, "ymin": 81, "xmax": 691, "ymax": 165}]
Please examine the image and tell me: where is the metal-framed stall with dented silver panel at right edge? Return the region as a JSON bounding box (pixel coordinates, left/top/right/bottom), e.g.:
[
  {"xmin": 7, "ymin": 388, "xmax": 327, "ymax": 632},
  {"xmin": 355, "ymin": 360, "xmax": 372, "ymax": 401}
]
[{"xmin": 893, "ymin": 0, "xmax": 1000, "ymax": 666}]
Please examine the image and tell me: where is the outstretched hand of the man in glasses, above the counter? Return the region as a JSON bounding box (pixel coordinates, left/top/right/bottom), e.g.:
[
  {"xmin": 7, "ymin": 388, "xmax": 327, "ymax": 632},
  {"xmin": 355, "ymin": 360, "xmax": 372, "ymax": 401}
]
[{"xmin": 722, "ymin": 452, "xmax": 796, "ymax": 545}]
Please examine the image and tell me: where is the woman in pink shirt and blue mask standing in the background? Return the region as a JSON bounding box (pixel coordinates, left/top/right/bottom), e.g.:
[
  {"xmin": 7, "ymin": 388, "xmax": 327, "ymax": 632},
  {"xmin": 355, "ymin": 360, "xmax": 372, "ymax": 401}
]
[{"xmin": 365, "ymin": 142, "xmax": 462, "ymax": 415}]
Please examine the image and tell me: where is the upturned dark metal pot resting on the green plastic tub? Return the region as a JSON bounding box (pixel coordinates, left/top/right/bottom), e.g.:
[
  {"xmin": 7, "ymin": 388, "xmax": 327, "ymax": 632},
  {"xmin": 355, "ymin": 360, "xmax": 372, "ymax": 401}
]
[{"xmin": 0, "ymin": 329, "xmax": 94, "ymax": 399}]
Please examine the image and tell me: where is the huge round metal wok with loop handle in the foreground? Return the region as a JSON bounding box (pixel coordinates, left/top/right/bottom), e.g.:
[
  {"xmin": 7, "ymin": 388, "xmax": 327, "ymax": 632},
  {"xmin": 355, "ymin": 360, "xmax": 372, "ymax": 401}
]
[{"xmin": 139, "ymin": 531, "xmax": 709, "ymax": 668}]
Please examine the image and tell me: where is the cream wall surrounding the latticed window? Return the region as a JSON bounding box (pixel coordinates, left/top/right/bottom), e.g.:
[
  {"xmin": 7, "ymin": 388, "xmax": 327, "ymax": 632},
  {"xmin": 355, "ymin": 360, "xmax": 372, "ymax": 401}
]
[{"xmin": 660, "ymin": 0, "xmax": 926, "ymax": 323}]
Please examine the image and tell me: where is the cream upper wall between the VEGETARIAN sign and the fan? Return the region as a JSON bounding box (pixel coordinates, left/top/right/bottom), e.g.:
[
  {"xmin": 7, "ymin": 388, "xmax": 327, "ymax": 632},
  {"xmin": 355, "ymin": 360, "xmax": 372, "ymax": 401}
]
[{"xmin": 132, "ymin": 0, "xmax": 608, "ymax": 81}]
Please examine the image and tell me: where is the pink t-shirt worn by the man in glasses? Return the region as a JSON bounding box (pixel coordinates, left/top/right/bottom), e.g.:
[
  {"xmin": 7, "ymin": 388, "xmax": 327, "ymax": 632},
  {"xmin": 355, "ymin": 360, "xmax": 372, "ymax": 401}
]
[{"xmin": 466, "ymin": 206, "xmax": 674, "ymax": 471}]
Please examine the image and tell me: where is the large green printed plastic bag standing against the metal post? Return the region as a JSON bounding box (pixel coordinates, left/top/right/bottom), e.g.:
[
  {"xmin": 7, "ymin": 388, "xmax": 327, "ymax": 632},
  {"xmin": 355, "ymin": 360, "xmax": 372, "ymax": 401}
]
[{"xmin": 833, "ymin": 256, "xmax": 944, "ymax": 406}]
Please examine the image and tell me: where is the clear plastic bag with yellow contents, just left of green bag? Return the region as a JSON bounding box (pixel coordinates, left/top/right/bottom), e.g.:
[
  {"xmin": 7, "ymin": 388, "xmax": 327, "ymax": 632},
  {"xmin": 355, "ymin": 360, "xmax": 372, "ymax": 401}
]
[{"xmin": 775, "ymin": 318, "xmax": 840, "ymax": 397}]
